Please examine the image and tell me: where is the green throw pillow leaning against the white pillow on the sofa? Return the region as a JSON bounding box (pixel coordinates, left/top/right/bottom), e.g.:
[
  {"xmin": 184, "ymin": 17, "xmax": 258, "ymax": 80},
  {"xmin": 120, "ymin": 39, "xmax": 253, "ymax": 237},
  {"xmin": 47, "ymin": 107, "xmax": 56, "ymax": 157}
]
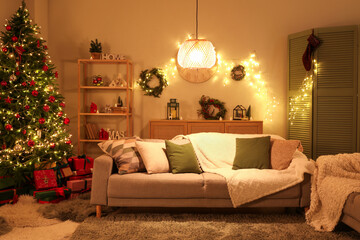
[{"xmin": 165, "ymin": 140, "xmax": 201, "ymax": 173}]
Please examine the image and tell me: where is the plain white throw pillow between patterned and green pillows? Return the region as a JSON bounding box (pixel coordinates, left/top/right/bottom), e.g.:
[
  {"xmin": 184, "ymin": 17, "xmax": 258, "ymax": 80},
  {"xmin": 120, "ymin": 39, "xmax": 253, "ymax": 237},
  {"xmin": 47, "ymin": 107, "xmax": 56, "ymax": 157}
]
[{"xmin": 136, "ymin": 141, "xmax": 170, "ymax": 173}]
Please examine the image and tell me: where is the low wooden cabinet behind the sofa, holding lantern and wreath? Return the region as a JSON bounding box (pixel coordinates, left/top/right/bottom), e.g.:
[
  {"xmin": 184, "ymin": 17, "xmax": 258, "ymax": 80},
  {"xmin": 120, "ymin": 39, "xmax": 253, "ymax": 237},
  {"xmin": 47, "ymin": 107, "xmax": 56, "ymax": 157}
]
[{"xmin": 150, "ymin": 120, "xmax": 263, "ymax": 139}]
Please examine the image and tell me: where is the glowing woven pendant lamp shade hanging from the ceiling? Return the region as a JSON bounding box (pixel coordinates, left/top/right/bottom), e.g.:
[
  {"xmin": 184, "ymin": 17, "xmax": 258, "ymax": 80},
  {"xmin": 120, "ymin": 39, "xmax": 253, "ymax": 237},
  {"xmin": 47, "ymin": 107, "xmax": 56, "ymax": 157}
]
[{"xmin": 177, "ymin": 39, "xmax": 216, "ymax": 69}]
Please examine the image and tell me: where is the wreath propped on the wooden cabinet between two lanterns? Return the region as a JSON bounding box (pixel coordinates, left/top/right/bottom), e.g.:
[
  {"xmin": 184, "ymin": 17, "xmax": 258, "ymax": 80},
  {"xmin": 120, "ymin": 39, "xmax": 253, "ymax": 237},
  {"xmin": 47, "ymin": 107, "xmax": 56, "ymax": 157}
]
[{"xmin": 198, "ymin": 95, "xmax": 226, "ymax": 120}]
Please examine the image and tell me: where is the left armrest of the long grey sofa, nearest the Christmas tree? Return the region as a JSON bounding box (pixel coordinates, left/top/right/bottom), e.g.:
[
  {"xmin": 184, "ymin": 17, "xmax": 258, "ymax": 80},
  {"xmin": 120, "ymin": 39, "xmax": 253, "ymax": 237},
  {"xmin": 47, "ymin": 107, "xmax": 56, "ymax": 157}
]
[{"xmin": 90, "ymin": 154, "xmax": 113, "ymax": 205}]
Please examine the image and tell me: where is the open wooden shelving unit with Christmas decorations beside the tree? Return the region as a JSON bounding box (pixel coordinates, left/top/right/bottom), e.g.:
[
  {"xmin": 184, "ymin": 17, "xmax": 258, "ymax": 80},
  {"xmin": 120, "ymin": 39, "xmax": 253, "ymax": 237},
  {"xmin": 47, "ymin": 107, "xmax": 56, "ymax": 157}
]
[{"xmin": 77, "ymin": 59, "xmax": 134, "ymax": 154}]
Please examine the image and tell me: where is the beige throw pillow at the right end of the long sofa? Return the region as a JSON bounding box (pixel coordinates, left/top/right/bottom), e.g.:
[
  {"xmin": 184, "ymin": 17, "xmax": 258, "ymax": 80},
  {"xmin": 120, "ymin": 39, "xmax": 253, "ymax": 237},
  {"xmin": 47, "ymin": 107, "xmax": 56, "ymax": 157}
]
[{"xmin": 270, "ymin": 139, "xmax": 302, "ymax": 170}]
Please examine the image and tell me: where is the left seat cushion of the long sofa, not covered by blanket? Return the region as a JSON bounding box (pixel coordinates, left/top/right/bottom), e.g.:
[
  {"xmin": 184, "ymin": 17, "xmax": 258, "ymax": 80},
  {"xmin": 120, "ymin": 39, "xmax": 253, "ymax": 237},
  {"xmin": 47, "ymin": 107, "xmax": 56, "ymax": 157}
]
[{"xmin": 108, "ymin": 172, "xmax": 204, "ymax": 199}]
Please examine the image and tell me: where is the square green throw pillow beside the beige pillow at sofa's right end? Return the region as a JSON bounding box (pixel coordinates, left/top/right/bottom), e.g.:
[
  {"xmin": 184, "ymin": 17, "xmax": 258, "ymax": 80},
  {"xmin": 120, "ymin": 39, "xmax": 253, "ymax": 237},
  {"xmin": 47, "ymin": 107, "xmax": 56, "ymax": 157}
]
[{"xmin": 232, "ymin": 136, "xmax": 270, "ymax": 170}]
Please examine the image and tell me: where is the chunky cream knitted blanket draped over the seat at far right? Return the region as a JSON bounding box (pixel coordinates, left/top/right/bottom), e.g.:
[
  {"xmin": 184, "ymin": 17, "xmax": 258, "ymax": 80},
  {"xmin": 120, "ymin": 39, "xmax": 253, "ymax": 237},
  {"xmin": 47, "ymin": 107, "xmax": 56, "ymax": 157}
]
[{"xmin": 305, "ymin": 153, "xmax": 360, "ymax": 231}]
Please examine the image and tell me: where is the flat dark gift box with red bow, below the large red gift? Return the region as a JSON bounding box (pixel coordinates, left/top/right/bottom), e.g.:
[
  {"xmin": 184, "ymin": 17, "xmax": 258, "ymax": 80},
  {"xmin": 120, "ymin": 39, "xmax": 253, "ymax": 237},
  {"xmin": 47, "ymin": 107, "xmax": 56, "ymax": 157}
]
[{"xmin": 33, "ymin": 187, "xmax": 71, "ymax": 203}]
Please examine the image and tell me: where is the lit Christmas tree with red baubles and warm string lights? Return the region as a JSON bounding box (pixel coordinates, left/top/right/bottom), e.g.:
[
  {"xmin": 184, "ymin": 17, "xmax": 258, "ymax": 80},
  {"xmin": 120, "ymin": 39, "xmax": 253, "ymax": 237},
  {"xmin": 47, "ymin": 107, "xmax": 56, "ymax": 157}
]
[{"xmin": 0, "ymin": 1, "xmax": 73, "ymax": 185}]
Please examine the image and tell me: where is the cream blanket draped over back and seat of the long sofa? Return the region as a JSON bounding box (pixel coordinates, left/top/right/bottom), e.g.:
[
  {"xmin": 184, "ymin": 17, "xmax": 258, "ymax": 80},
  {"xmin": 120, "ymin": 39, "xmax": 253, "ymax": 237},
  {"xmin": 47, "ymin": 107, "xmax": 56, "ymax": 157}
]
[{"xmin": 185, "ymin": 133, "xmax": 315, "ymax": 207}]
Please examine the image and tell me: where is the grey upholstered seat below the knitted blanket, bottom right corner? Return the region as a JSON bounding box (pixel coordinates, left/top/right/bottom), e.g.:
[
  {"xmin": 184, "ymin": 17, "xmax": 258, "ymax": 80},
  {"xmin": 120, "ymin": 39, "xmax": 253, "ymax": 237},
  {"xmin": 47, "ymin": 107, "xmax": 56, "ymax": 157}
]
[{"xmin": 341, "ymin": 192, "xmax": 360, "ymax": 233}]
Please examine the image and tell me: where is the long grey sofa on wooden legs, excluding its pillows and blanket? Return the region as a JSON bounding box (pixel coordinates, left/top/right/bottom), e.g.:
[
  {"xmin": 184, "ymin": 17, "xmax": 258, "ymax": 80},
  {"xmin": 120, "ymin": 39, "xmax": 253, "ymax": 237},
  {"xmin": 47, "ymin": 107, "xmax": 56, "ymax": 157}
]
[{"xmin": 90, "ymin": 155, "xmax": 310, "ymax": 217}]
